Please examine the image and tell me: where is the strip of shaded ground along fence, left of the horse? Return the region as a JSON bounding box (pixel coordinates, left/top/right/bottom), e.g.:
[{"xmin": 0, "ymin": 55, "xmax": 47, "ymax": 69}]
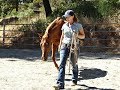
[{"xmin": 0, "ymin": 49, "xmax": 41, "ymax": 61}]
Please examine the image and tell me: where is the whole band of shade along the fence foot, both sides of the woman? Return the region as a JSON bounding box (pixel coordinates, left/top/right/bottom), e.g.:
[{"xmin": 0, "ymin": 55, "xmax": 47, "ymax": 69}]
[{"xmin": 0, "ymin": 49, "xmax": 120, "ymax": 62}]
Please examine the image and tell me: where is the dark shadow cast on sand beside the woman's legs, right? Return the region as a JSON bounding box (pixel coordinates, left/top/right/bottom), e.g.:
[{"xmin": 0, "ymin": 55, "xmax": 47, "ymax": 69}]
[{"xmin": 65, "ymin": 67, "xmax": 115, "ymax": 90}]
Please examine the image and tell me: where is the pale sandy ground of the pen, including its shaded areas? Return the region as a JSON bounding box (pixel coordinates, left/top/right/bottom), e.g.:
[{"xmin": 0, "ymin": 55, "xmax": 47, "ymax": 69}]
[{"xmin": 0, "ymin": 49, "xmax": 120, "ymax": 90}]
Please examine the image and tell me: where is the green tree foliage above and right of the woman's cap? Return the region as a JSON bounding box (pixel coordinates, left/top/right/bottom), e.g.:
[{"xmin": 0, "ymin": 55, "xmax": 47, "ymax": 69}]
[{"xmin": 52, "ymin": 0, "xmax": 120, "ymax": 19}]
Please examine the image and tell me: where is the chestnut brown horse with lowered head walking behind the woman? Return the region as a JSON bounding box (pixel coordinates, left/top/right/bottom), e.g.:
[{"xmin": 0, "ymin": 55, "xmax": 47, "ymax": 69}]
[{"xmin": 40, "ymin": 17, "xmax": 65, "ymax": 69}]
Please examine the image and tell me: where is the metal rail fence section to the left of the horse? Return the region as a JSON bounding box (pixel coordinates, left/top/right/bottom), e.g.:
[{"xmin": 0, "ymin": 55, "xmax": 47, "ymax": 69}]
[{"xmin": 0, "ymin": 24, "xmax": 43, "ymax": 48}]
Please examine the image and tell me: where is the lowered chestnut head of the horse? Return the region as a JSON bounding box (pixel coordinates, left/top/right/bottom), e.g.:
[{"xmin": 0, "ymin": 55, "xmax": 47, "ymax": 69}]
[{"xmin": 40, "ymin": 35, "xmax": 51, "ymax": 61}]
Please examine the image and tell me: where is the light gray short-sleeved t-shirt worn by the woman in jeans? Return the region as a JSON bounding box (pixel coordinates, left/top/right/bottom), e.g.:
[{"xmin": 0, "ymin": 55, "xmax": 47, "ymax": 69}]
[{"xmin": 61, "ymin": 22, "xmax": 83, "ymax": 44}]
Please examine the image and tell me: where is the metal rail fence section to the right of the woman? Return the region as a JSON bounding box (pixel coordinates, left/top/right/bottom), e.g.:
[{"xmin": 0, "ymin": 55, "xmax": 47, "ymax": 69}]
[{"xmin": 81, "ymin": 23, "xmax": 120, "ymax": 52}]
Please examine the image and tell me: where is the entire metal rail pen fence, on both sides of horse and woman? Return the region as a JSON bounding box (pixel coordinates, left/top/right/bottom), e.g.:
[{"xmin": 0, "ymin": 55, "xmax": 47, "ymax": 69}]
[{"xmin": 0, "ymin": 23, "xmax": 120, "ymax": 52}]
